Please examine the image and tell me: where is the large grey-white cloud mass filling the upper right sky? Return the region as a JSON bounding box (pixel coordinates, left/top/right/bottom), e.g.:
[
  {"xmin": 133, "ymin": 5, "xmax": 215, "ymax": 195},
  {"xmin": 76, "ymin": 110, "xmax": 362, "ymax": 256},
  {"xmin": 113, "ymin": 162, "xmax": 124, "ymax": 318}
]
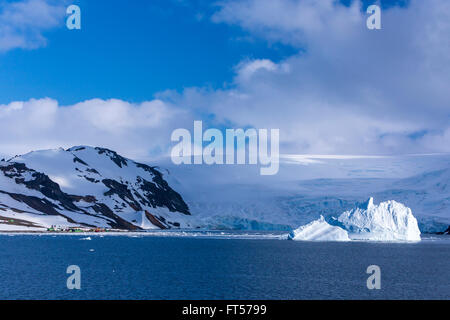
[{"xmin": 196, "ymin": 0, "xmax": 450, "ymax": 154}]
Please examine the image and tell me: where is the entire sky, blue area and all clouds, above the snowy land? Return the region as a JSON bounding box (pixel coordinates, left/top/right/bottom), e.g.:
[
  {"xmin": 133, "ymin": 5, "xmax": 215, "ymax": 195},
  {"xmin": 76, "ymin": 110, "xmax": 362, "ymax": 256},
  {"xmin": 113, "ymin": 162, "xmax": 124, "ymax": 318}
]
[{"xmin": 0, "ymin": 0, "xmax": 450, "ymax": 159}]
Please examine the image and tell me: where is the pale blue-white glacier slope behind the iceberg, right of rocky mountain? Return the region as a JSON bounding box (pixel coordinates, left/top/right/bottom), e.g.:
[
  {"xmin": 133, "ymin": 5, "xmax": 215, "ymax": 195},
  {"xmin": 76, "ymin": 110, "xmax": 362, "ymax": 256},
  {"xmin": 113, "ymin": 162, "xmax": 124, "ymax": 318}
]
[{"xmin": 166, "ymin": 154, "xmax": 450, "ymax": 233}]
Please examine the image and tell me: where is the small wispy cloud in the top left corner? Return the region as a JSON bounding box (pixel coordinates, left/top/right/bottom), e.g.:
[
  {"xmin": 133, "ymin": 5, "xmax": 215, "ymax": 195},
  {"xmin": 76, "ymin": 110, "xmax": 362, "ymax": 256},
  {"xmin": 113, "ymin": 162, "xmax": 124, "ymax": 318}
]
[{"xmin": 0, "ymin": 0, "xmax": 65, "ymax": 52}]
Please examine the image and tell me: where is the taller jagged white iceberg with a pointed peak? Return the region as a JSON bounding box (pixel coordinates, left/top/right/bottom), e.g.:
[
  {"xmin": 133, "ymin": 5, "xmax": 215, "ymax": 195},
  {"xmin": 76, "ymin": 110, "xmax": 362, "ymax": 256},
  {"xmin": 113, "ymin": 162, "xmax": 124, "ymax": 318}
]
[{"xmin": 337, "ymin": 197, "xmax": 420, "ymax": 241}]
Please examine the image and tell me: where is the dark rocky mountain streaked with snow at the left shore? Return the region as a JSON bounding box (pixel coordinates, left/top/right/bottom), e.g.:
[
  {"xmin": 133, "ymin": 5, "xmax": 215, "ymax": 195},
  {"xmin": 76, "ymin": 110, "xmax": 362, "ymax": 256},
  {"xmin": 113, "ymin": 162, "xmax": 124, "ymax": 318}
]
[{"xmin": 0, "ymin": 146, "xmax": 190, "ymax": 230}]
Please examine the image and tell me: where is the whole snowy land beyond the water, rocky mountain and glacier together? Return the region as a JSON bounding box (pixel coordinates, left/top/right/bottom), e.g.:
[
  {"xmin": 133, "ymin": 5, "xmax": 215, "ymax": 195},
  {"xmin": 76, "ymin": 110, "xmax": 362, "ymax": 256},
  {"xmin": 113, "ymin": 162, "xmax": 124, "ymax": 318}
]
[{"xmin": 0, "ymin": 146, "xmax": 450, "ymax": 233}]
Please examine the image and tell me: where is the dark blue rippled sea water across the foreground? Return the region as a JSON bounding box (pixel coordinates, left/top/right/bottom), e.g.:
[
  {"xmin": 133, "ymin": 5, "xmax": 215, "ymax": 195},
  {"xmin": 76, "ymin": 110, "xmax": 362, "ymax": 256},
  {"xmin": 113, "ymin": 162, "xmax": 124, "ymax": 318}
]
[{"xmin": 0, "ymin": 235, "xmax": 450, "ymax": 299}]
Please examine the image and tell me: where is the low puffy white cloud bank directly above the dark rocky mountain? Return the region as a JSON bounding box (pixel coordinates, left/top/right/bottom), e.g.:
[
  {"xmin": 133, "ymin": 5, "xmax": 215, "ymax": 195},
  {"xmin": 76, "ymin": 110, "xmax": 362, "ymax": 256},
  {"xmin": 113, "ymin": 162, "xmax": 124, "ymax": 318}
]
[{"xmin": 0, "ymin": 98, "xmax": 193, "ymax": 159}]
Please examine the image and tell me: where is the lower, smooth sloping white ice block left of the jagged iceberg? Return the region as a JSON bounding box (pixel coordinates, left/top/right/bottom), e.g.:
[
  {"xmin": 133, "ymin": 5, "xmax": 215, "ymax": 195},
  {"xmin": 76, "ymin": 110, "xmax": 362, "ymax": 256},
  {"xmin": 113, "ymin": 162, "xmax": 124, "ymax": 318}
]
[{"xmin": 288, "ymin": 216, "xmax": 350, "ymax": 241}]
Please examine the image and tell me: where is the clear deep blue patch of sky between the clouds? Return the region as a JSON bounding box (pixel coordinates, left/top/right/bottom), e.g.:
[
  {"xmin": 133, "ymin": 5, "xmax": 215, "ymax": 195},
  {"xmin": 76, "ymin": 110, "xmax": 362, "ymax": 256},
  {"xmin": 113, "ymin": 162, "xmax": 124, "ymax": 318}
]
[{"xmin": 0, "ymin": 0, "xmax": 293, "ymax": 105}]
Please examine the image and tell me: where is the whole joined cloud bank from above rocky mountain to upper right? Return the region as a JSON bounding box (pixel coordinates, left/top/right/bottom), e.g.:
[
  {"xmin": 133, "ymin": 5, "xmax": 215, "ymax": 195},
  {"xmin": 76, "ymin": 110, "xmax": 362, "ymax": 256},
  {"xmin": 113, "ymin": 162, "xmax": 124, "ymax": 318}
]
[{"xmin": 0, "ymin": 0, "xmax": 450, "ymax": 158}]
